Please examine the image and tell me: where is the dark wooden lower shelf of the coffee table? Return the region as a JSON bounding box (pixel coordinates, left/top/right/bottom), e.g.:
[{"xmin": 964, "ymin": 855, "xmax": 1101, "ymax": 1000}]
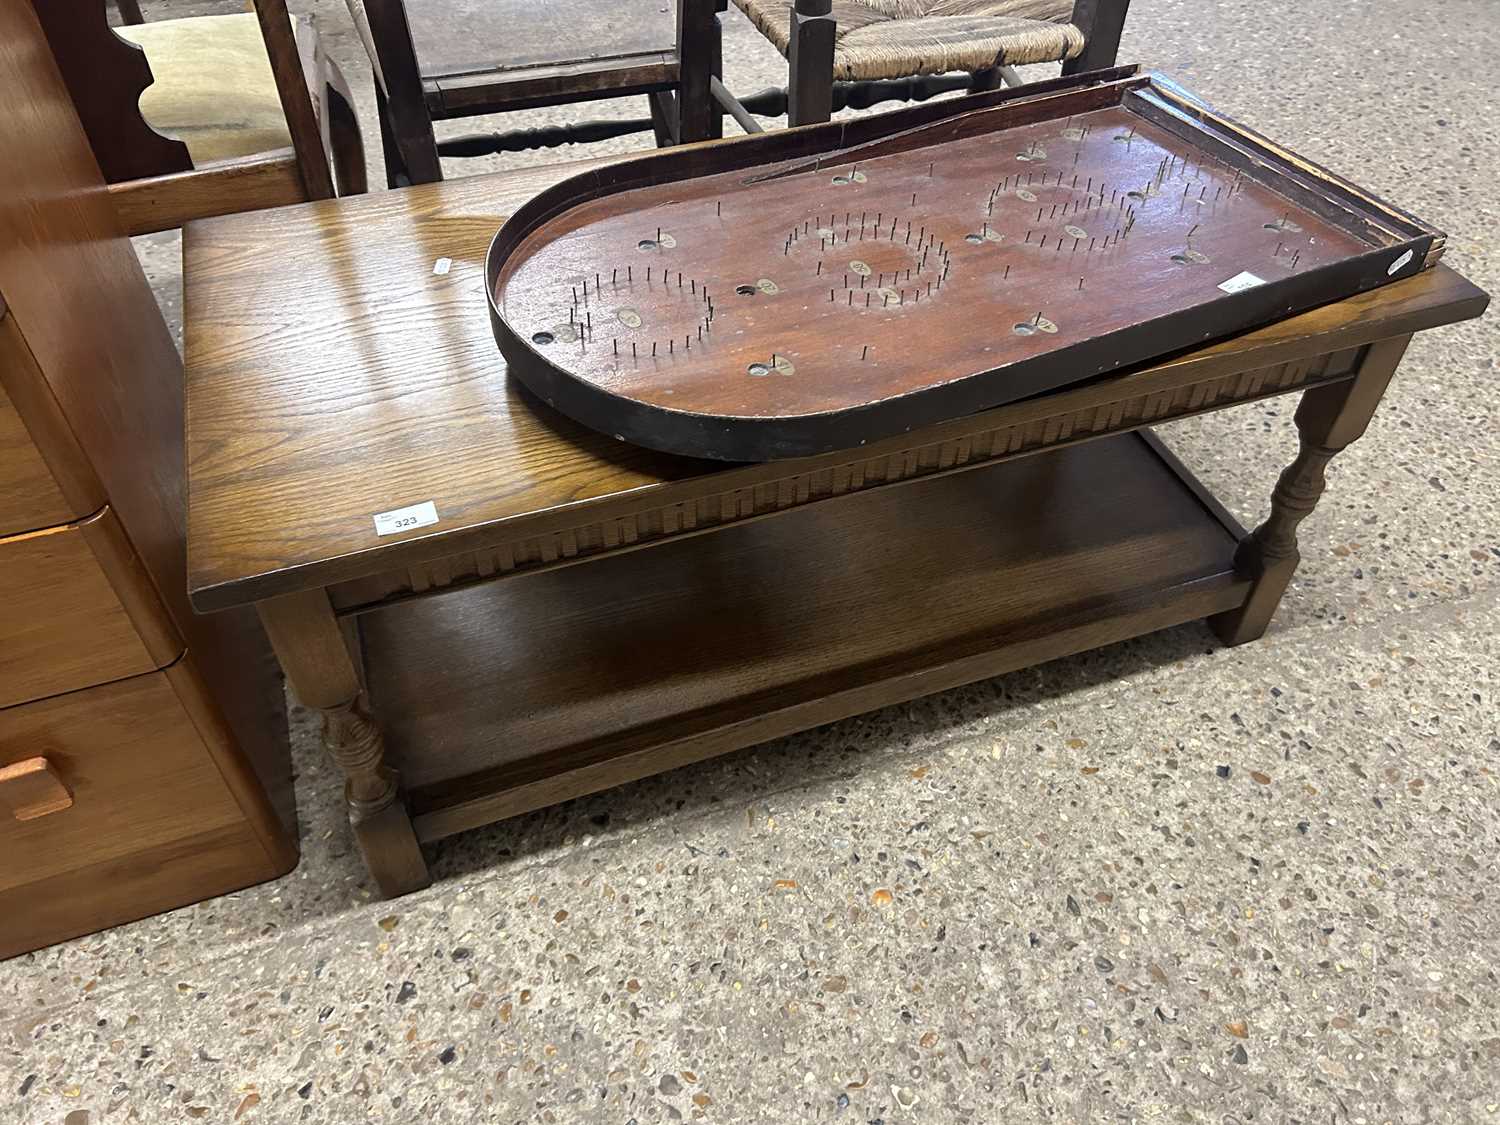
[{"xmin": 362, "ymin": 434, "xmax": 1248, "ymax": 840}]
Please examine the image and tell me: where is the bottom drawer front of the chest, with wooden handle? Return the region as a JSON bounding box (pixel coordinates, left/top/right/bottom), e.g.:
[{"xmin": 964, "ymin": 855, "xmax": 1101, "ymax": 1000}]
[{"xmin": 0, "ymin": 672, "xmax": 243, "ymax": 891}]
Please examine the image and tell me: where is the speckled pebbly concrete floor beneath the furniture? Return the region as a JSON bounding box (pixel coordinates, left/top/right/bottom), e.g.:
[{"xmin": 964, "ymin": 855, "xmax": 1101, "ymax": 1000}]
[{"xmin": 0, "ymin": 0, "xmax": 1500, "ymax": 1125}]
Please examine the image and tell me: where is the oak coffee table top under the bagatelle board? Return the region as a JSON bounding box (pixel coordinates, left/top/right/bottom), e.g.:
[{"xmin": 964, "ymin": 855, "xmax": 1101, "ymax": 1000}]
[{"xmin": 183, "ymin": 147, "xmax": 1485, "ymax": 611}]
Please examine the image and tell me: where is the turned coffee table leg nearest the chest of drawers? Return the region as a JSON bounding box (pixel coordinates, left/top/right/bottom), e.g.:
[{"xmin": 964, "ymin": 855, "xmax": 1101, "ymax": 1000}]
[{"xmin": 257, "ymin": 590, "xmax": 431, "ymax": 897}]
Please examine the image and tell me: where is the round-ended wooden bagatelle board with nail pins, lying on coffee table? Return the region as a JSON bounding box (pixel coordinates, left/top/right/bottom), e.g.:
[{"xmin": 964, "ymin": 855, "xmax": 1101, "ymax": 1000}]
[{"xmin": 486, "ymin": 68, "xmax": 1443, "ymax": 461}]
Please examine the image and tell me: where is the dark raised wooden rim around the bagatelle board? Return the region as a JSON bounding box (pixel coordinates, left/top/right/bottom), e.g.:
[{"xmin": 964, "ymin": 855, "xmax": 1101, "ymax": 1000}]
[{"xmin": 485, "ymin": 68, "xmax": 1440, "ymax": 462}]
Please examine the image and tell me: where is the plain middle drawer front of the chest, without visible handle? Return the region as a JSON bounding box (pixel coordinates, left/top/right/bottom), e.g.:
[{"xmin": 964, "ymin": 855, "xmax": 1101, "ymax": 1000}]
[{"xmin": 0, "ymin": 509, "xmax": 182, "ymax": 707}]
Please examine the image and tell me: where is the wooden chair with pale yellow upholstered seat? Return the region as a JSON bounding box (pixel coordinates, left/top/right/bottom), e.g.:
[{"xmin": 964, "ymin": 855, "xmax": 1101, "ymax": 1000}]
[{"xmin": 33, "ymin": 0, "xmax": 366, "ymax": 234}]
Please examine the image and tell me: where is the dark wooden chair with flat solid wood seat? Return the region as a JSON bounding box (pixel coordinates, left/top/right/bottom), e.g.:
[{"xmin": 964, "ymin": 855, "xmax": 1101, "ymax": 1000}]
[{"xmin": 345, "ymin": 0, "xmax": 728, "ymax": 188}]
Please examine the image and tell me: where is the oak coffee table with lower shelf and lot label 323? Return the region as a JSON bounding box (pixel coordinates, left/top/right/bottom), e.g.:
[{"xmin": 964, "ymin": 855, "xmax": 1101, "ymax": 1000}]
[{"xmin": 183, "ymin": 152, "xmax": 1487, "ymax": 896}]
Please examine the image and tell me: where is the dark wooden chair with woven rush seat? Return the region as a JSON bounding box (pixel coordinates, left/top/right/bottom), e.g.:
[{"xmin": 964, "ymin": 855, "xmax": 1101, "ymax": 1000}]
[{"xmin": 729, "ymin": 0, "xmax": 1130, "ymax": 125}]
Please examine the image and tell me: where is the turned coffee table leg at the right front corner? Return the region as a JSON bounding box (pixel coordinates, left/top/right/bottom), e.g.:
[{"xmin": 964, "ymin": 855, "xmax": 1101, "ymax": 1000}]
[{"xmin": 1209, "ymin": 336, "xmax": 1412, "ymax": 645}]
